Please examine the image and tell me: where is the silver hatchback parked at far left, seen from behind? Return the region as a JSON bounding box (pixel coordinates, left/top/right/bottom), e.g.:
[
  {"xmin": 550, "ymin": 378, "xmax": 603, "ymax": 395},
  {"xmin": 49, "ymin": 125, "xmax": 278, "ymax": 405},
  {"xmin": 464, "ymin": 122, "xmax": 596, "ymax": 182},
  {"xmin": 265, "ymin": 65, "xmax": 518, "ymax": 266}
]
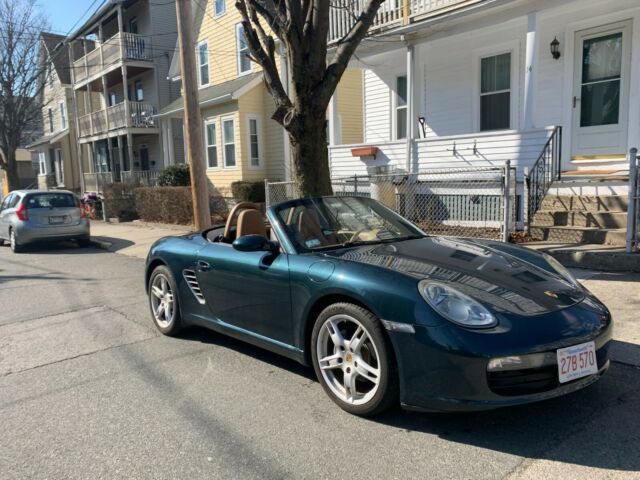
[{"xmin": 0, "ymin": 190, "xmax": 90, "ymax": 253}]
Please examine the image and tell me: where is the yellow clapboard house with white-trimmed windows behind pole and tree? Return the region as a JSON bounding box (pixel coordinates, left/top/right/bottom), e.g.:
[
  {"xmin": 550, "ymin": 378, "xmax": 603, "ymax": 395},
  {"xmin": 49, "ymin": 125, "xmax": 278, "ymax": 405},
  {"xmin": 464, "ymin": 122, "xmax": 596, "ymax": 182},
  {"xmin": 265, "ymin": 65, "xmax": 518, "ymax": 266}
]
[{"xmin": 158, "ymin": 0, "xmax": 363, "ymax": 197}]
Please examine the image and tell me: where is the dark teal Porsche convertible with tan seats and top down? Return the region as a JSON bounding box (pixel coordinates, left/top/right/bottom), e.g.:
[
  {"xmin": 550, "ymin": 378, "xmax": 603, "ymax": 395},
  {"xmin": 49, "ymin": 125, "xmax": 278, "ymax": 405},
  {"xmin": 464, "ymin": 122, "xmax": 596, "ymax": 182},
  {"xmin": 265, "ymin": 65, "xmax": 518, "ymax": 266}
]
[{"xmin": 145, "ymin": 197, "xmax": 612, "ymax": 415}]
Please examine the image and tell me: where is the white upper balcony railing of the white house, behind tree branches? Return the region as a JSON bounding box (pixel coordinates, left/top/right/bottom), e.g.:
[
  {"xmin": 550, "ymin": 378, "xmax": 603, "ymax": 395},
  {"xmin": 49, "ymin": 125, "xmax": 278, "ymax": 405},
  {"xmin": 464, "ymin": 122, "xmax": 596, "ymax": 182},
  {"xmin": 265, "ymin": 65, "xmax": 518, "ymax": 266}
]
[{"xmin": 328, "ymin": 0, "xmax": 482, "ymax": 44}]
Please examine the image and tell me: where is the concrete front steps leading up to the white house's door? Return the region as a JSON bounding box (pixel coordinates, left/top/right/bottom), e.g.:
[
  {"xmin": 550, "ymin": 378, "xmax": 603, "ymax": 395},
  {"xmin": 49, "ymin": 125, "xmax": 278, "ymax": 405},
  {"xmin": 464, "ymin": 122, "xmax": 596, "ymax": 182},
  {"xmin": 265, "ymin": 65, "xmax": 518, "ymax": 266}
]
[{"xmin": 529, "ymin": 195, "xmax": 628, "ymax": 247}]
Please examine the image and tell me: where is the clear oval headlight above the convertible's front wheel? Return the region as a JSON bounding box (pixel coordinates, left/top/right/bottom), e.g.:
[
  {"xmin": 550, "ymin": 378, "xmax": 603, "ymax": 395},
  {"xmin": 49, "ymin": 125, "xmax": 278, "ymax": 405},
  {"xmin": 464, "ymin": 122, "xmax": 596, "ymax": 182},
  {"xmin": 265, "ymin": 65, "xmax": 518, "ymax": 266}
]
[{"xmin": 418, "ymin": 280, "xmax": 498, "ymax": 328}]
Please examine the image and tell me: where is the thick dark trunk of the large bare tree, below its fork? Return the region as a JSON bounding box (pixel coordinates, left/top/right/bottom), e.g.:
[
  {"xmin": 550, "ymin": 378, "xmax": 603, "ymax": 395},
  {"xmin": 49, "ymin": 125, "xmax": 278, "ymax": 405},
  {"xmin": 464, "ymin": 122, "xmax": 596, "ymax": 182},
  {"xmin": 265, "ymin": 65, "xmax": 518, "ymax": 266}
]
[{"xmin": 289, "ymin": 114, "xmax": 333, "ymax": 197}]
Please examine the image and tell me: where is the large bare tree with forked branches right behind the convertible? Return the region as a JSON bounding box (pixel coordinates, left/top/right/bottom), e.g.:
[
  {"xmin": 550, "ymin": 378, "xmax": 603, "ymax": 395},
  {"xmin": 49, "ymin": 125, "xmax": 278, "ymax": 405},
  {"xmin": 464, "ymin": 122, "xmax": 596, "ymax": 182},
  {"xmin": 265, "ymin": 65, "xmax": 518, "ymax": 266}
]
[{"xmin": 236, "ymin": 0, "xmax": 384, "ymax": 195}]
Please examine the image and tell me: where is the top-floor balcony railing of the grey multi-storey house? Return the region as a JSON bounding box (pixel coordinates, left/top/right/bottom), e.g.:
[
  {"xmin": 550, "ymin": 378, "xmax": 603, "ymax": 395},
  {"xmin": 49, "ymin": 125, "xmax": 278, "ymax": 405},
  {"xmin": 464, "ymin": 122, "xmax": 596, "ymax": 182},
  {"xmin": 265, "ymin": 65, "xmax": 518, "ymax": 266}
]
[{"xmin": 73, "ymin": 32, "xmax": 152, "ymax": 85}]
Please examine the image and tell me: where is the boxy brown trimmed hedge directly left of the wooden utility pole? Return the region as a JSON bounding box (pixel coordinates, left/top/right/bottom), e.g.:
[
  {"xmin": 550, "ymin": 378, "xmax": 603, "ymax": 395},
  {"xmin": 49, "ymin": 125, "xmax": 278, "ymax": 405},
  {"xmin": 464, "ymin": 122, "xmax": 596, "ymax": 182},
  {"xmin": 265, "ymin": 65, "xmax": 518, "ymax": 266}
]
[{"xmin": 134, "ymin": 187, "xmax": 193, "ymax": 225}]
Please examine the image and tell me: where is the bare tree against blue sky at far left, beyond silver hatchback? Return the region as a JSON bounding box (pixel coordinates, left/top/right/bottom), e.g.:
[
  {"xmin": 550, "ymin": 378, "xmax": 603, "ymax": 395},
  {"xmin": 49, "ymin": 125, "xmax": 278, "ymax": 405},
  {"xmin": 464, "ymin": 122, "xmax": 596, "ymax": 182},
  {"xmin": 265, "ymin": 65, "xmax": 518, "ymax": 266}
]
[{"xmin": 0, "ymin": 0, "xmax": 47, "ymax": 190}]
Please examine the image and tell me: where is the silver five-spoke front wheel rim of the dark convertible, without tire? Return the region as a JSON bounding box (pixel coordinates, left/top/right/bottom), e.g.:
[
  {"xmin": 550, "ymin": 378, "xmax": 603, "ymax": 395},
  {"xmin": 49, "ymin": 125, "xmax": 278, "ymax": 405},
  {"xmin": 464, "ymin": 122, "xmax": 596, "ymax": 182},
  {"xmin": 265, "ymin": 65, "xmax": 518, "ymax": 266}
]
[{"xmin": 316, "ymin": 314, "xmax": 380, "ymax": 405}]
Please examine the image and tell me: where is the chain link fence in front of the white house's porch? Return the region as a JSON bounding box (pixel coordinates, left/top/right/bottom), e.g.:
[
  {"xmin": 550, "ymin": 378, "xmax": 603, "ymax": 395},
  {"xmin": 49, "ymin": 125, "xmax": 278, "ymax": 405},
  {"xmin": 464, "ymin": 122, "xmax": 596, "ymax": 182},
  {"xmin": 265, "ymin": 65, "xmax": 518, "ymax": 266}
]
[{"xmin": 265, "ymin": 162, "xmax": 519, "ymax": 241}]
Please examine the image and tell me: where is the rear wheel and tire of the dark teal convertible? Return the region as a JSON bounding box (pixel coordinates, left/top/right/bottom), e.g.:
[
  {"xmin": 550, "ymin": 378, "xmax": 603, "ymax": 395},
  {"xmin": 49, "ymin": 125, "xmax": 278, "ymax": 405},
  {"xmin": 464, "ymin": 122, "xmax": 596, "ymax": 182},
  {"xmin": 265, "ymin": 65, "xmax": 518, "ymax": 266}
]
[{"xmin": 147, "ymin": 265, "xmax": 182, "ymax": 336}]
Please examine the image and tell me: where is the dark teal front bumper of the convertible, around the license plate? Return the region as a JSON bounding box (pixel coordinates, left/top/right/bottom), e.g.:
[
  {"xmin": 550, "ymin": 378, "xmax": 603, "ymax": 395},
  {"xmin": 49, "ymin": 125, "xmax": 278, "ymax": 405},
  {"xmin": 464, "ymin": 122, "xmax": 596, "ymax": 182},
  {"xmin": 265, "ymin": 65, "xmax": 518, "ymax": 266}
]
[{"xmin": 389, "ymin": 304, "xmax": 612, "ymax": 411}]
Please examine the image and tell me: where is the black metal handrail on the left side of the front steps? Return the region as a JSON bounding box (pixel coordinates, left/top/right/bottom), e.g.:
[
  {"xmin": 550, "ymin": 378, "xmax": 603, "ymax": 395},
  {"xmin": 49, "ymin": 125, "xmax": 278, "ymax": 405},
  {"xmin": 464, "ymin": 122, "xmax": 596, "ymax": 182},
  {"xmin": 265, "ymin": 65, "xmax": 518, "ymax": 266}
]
[{"xmin": 525, "ymin": 126, "xmax": 562, "ymax": 223}]
